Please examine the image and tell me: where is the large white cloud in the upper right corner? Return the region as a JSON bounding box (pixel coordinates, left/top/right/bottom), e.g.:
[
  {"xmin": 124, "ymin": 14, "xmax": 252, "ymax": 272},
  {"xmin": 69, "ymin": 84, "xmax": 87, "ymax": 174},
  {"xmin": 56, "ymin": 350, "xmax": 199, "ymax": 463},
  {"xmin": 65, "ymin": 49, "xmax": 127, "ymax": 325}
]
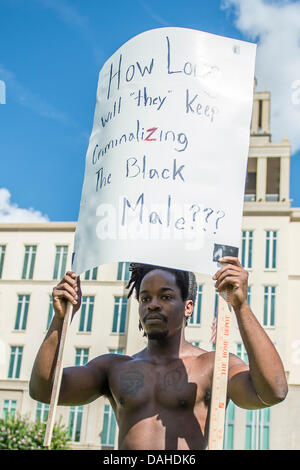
[{"xmin": 222, "ymin": 0, "xmax": 300, "ymax": 152}]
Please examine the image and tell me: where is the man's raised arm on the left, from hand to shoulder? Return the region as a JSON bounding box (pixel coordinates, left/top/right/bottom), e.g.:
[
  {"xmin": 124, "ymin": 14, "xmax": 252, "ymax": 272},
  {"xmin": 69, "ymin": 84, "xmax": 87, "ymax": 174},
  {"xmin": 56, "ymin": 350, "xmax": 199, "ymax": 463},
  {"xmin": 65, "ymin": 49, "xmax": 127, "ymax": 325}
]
[{"xmin": 29, "ymin": 271, "xmax": 107, "ymax": 405}]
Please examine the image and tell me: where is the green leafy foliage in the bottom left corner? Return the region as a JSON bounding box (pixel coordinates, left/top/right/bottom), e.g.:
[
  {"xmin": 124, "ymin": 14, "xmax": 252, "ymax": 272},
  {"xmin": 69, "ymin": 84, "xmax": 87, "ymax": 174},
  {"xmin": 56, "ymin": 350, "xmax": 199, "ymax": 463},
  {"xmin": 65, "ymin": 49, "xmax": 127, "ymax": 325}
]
[{"xmin": 0, "ymin": 415, "xmax": 70, "ymax": 450}]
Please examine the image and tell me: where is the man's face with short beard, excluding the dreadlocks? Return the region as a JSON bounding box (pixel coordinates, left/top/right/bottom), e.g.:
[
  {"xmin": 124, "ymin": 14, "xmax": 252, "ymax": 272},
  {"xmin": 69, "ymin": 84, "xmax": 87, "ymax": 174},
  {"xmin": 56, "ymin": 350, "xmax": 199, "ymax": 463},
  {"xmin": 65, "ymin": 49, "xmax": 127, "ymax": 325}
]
[{"xmin": 138, "ymin": 269, "xmax": 191, "ymax": 339}]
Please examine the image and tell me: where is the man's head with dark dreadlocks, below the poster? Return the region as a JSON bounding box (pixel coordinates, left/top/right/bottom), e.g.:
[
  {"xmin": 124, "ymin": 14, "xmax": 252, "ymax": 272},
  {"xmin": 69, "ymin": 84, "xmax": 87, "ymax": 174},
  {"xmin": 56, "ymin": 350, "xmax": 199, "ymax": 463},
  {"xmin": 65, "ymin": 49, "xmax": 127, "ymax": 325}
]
[{"xmin": 127, "ymin": 263, "xmax": 197, "ymax": 339}]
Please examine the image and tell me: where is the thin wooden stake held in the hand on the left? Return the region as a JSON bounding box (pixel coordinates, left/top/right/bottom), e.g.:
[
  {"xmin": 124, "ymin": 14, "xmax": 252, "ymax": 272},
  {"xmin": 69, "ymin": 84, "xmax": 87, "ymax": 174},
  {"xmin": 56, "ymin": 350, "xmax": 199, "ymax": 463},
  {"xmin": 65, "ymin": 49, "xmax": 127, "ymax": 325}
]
[{"xmin": 44, "ymin": 302, "xmax": 73, "ymax": 449}]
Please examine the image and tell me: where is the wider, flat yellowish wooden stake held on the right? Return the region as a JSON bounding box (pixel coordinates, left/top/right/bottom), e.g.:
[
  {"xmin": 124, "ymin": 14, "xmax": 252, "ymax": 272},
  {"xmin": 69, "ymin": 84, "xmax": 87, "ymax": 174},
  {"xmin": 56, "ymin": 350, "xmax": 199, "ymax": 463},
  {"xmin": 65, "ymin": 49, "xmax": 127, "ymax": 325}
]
[{"xmin": 208, "ymin": 295, "xmax": 230, "ymax": 450}]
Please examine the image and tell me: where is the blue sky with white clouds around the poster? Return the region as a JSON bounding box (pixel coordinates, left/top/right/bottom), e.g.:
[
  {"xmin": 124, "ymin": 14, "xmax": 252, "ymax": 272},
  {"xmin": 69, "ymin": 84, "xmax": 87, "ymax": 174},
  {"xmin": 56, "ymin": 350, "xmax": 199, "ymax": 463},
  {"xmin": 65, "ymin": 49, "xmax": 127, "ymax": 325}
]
[{"xmin": 0, "ymin": 0, "xmax": 300, "ymax": 222}]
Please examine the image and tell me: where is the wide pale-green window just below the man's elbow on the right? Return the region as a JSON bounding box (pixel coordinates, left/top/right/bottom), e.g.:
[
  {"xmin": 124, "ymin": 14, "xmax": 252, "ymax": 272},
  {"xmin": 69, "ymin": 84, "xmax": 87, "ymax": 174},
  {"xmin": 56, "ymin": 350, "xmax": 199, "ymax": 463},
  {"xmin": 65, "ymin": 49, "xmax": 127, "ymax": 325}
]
[{"xmin": 245, "ymin": 408, "xmax": 270, "ymax": 450}]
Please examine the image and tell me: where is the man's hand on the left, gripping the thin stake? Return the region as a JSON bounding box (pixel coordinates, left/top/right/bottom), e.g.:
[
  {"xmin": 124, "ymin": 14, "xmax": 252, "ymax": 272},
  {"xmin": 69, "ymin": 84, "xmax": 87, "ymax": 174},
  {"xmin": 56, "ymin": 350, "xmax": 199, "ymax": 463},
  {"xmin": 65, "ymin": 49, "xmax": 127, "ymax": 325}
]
[{"xmin": 52, "ymin": 271, "xmax": 81, "ymax": 318}]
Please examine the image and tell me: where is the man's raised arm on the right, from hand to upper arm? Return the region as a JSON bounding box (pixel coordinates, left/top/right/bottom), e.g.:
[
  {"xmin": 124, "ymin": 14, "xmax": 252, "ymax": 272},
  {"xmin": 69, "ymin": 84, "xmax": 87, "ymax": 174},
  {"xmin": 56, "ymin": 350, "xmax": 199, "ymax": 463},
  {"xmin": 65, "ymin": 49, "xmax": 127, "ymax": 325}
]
[{"xmin": 214, "ymin": 256, "xmax": 288, "ymax": 409}]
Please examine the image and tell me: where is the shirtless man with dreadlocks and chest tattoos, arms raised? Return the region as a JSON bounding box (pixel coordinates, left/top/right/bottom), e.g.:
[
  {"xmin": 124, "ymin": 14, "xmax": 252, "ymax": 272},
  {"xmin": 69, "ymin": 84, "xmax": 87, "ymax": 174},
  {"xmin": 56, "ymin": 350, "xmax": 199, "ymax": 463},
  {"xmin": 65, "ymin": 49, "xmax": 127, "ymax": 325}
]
[{"xmin": 30, "ymin": 257, "xmax": 287, "ymax": 450}]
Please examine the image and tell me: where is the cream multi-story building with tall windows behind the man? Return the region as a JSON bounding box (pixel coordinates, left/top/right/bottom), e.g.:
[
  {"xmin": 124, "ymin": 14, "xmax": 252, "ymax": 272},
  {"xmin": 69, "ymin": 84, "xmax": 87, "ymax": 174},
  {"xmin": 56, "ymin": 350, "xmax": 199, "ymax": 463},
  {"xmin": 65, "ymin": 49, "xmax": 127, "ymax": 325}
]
[{"xmin": 0, "ymin": 82, "xmax": 300, "ymax": 449}]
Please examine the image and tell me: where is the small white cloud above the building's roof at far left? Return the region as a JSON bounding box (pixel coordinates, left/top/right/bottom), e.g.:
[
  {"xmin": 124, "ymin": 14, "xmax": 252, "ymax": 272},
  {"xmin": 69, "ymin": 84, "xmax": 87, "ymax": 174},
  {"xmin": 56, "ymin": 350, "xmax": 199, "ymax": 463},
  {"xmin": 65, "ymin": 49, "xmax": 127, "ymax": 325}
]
[{"xmin": 0, "ymin": 188, "xmax": 49, "ymax": 223}]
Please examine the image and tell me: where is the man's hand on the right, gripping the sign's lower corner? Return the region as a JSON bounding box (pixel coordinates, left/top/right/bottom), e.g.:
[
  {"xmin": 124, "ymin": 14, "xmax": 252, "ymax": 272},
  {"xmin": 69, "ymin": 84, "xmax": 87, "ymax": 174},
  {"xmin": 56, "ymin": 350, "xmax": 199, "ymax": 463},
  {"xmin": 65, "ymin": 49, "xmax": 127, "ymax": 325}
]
[{"xmin": 213, "ymin": 256, "xmax": 248, "ymax": 311}]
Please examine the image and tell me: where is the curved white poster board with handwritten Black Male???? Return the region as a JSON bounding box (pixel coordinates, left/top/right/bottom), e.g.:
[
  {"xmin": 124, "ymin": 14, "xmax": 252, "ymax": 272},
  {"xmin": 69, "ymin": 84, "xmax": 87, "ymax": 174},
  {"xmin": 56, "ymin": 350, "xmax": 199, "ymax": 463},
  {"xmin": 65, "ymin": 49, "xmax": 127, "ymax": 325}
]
[{"xmin": 72, "ymin": 28, "xmax": 256, "ymax": 274}]
